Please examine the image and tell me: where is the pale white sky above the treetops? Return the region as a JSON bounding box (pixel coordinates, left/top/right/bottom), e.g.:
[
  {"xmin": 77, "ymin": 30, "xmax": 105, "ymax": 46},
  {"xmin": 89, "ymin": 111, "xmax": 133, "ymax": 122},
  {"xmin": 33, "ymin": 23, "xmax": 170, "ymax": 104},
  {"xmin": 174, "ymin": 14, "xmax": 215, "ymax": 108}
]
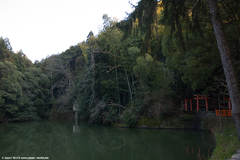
[{"xmin": 0, "ymin": 0, "xmax": 139, "ymax": 63}]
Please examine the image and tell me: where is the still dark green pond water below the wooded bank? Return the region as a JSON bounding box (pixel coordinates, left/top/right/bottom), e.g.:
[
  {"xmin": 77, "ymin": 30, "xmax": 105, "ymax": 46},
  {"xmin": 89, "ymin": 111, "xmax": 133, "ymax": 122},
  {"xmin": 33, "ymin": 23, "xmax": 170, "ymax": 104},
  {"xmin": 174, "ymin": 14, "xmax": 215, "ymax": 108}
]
[{"xmin": 0, "ymin": 121, "xmax": 215, "ymax": 160}]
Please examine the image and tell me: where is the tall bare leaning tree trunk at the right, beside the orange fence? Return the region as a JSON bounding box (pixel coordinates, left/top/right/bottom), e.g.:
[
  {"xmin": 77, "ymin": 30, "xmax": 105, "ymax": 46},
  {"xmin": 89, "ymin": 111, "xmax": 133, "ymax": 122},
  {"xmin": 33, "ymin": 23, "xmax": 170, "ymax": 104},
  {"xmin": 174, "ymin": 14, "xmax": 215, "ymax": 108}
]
[{"xmin": 207, "ymin": 0, "xmax": 240, "ymax": 141}]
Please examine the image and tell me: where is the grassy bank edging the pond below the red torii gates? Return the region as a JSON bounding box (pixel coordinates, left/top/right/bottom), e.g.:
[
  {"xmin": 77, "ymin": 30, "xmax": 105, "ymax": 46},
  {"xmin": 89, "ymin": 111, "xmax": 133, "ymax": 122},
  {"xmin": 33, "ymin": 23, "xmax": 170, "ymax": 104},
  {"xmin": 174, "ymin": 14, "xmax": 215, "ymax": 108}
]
[{"xmin": 113, "ymin": 114, "xmax": 240, "ymax": 160}]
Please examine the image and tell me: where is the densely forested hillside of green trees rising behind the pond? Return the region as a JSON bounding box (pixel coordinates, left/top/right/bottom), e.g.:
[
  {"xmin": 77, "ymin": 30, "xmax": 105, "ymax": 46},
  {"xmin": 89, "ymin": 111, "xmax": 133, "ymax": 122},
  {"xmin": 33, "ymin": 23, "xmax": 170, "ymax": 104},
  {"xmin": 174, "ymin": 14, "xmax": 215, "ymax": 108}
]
[{"xmin": 0, "ymin": 0, "xmax": 240, "ymax": 129}]
